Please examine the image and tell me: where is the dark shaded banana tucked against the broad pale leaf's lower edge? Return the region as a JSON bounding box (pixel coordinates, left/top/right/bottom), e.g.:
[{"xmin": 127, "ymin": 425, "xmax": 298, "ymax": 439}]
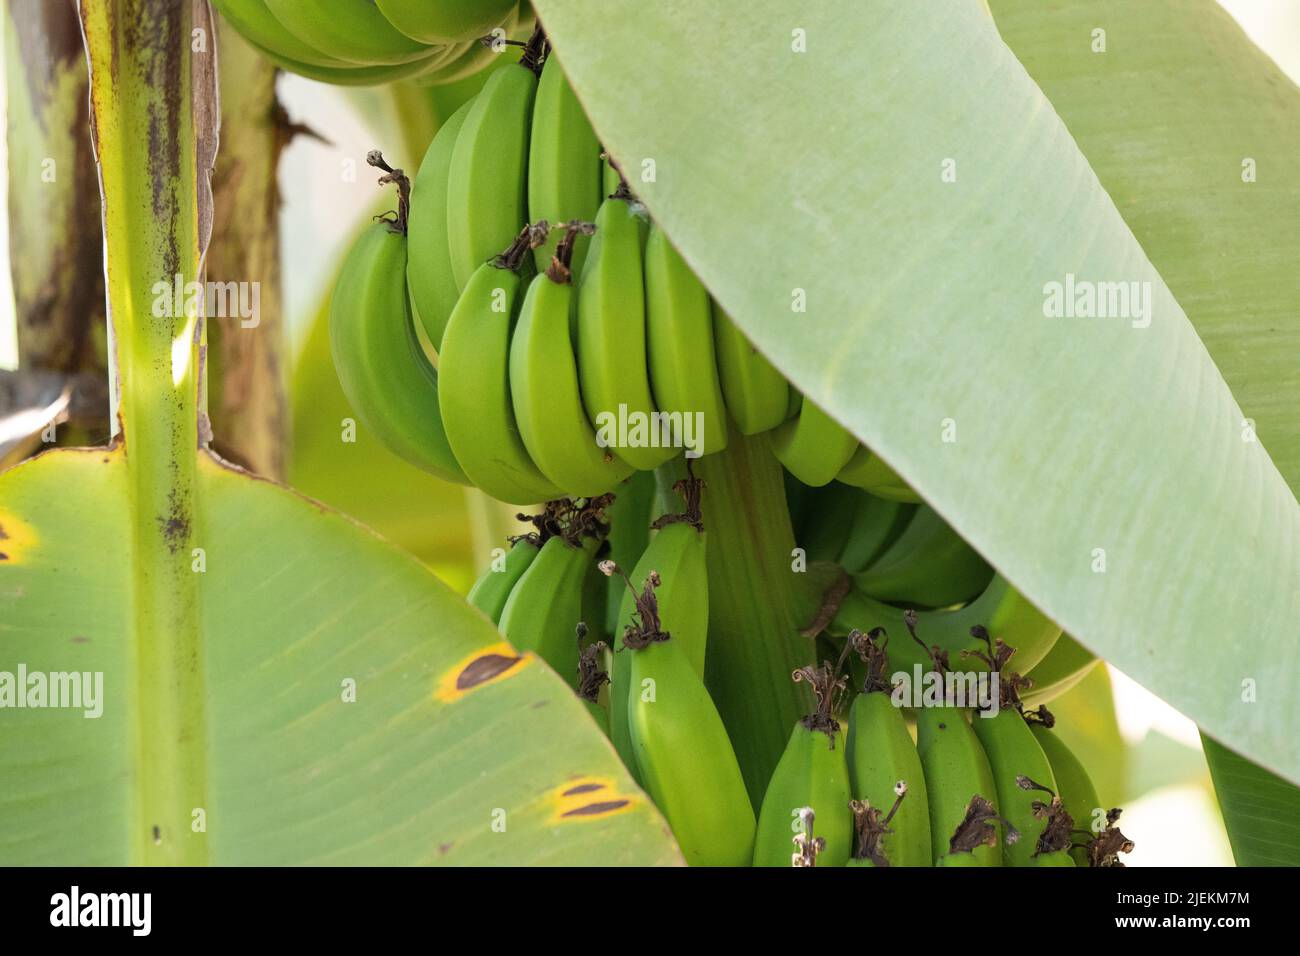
[{"xmin": 853, "ymin": 505, "xmax": 993, "ymax": 607}]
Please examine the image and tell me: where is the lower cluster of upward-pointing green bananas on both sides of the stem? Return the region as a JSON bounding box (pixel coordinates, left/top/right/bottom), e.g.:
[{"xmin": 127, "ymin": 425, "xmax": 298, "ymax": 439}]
[{"xmin": 469, "ymin": 479, "xmax": 1132, "ymax": 866}]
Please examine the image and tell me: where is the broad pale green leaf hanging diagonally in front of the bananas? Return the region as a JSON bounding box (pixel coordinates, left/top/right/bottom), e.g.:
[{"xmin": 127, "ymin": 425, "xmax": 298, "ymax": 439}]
[{"xmin": 536, "ymin": 0, "xmax": 1300, "ymax": 780}]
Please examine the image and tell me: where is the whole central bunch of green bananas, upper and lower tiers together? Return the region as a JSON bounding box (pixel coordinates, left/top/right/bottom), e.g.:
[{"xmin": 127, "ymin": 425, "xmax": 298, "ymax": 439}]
[{"xmin": 330, "ymin": 22, "xmax": 1131, "ymax": 866}]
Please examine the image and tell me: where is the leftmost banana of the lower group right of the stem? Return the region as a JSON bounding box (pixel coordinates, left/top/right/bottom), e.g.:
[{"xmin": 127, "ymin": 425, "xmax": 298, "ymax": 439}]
[{"xmin": 754, "ymin": 656, "xmax": 853, "ymax": 866}]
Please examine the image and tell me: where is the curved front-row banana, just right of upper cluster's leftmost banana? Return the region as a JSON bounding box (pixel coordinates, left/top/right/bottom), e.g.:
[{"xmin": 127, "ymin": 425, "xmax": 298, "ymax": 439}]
[{"xmin": 438, "ymin": 228, "xmax": 564, "ymax": 505}]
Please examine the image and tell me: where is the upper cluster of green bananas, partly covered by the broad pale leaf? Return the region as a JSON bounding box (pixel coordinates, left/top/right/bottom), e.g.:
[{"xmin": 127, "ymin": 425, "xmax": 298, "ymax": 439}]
[{"xmin": 332, "ymin": 30, "xmax": 915, "ymax": 505}]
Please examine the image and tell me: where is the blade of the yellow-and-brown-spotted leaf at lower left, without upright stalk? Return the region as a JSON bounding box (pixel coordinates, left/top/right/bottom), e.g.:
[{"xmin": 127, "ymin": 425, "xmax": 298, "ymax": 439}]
[{"xmin": 0, "ymin": 447, "xmax": 677, "ymax": 865}]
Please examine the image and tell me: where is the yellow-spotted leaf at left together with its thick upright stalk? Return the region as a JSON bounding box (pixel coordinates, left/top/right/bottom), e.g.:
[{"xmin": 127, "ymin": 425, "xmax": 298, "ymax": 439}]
[{"xmin": 0, "ymin": 0, "xmax": 680, "ymax": 864}]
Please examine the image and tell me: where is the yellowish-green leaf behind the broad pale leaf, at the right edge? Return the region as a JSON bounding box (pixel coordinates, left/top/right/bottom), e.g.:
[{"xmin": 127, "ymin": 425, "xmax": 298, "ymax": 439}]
[{"xmin": 993, "ymin": 0, "xmax": 1300, "ymax": 865}]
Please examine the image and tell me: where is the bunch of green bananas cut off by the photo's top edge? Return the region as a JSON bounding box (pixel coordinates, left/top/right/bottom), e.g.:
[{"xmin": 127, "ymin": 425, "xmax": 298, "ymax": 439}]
[{"xmin": 213, "ymin": 0, "xmax": 522, "ymax": 86}]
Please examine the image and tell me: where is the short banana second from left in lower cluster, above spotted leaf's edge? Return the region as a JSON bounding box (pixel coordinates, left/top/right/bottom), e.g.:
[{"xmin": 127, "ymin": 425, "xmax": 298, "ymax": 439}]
[{"xmin": 501, "ymin": 506, "xmax": 601, "ymax": 687}]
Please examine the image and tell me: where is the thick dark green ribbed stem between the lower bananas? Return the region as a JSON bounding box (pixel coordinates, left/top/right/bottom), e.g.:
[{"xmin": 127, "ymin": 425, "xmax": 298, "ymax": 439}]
[{"xmin": 691, "ymin": 431, "xmax": 814, "ymax": 806}]
